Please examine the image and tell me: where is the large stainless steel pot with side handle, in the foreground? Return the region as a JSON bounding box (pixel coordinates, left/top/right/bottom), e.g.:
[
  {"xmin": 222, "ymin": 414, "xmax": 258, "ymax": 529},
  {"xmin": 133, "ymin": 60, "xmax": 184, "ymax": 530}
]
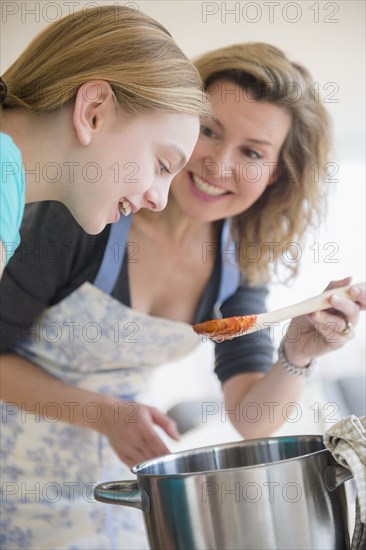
[{"xmin": 94, "ymin": 435, "xmax": 351, "ymax": 550}]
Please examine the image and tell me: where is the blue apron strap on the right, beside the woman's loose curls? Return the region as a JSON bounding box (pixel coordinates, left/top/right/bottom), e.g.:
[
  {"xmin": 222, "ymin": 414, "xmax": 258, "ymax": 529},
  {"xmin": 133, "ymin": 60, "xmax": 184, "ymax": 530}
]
[{"xmin": 214, "ymin": 220, "xmax": 240, "ymax": 317}]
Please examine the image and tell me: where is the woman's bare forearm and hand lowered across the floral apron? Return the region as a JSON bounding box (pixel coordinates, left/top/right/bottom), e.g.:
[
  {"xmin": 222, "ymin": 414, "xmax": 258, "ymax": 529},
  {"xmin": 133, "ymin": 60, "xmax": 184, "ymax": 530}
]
[{"xmin": 0, "ymin": 354, "xmax": 179, "ymax": 466}]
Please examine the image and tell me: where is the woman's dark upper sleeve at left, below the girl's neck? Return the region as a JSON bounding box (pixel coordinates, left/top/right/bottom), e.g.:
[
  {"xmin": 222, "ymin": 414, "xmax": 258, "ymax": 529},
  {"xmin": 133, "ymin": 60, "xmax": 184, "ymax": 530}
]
[{"xmin": 0, "ymin": 202, "xmax": 93, "ymax": 353}]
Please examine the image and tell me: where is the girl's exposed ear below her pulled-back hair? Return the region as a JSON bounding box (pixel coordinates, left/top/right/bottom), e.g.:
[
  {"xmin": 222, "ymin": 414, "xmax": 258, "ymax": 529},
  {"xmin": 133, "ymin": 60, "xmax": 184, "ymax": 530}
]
[{"xmin": 73, "ymin": 80, "xmax": 115, "ymax": 145}]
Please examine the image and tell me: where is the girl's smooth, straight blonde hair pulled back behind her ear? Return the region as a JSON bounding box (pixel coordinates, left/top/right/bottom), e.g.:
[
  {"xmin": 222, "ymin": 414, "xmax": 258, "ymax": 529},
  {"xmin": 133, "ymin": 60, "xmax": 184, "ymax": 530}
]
[{"xmin": 2, "ymin": 5, "xmax": 208, "ymax": 115}]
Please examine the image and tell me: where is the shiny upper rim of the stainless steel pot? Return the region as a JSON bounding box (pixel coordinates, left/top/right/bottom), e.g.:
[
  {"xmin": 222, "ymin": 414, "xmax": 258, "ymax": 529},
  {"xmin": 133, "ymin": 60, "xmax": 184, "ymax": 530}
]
[{"xmin": 130, "ymin": 434, "xmax": 331, "ymax": 478}]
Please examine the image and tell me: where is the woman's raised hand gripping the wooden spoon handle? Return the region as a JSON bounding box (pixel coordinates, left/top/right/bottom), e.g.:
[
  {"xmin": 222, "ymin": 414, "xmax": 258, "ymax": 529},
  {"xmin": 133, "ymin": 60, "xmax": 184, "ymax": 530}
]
[{"xmin": 285, "ymin": 277, "xmax": 366, "ymax": 367}]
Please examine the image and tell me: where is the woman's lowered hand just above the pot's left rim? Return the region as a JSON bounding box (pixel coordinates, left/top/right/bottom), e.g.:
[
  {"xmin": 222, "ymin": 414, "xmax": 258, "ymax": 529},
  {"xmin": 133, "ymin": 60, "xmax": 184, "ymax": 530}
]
[{"xmin": 100, "ymin": 397, "xmax": 179, "ymax": 466}]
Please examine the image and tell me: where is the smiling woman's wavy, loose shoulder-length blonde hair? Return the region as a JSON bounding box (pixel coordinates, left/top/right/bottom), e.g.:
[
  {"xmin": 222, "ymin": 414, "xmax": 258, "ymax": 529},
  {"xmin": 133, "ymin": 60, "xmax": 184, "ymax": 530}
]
[{"xmin": 195, "ymin": 43, "xmax": 330, "ymax": 285}]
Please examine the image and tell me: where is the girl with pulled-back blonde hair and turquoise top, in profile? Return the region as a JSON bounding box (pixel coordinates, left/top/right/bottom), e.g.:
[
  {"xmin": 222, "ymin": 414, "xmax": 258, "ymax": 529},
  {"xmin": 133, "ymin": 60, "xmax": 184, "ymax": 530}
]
[{"xmin": 0, "ymin": 5, "xmax": 207, "ymax": 278}]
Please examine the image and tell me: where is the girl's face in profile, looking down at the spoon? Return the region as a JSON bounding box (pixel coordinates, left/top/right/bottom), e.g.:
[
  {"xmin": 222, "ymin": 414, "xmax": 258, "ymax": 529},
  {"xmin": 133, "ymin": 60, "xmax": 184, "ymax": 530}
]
[{"xmin": 65, "ymin": 103, "xmax": 199, "ymax": 234}]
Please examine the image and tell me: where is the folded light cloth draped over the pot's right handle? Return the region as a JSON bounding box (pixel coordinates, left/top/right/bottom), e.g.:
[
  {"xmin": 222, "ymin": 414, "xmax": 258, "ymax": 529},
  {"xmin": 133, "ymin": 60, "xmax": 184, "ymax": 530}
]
[{"xmin": 323, "ymin": 415, "xmax": 366, "ymax": 550}]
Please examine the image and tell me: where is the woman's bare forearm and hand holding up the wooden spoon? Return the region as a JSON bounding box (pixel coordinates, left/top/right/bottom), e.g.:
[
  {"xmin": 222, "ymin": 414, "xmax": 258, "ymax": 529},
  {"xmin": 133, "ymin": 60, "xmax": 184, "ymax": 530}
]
[{"xmin": 223, "ymin": 278, "xmax": 366, "ymax": 438}]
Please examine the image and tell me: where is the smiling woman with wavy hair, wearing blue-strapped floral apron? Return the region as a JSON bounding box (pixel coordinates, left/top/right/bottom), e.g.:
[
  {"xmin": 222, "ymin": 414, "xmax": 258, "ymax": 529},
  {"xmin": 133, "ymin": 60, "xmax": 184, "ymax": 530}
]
[{"xmin": 1, "ymin": 44, "xmax": 365, "ymax": 548}]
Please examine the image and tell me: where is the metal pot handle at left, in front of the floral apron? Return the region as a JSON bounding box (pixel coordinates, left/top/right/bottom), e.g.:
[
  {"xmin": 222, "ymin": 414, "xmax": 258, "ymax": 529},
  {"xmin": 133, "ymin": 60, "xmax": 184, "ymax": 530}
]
[{"xmin": 94, "ymin": 480, "xmax": 150, "ymax": 513}]
